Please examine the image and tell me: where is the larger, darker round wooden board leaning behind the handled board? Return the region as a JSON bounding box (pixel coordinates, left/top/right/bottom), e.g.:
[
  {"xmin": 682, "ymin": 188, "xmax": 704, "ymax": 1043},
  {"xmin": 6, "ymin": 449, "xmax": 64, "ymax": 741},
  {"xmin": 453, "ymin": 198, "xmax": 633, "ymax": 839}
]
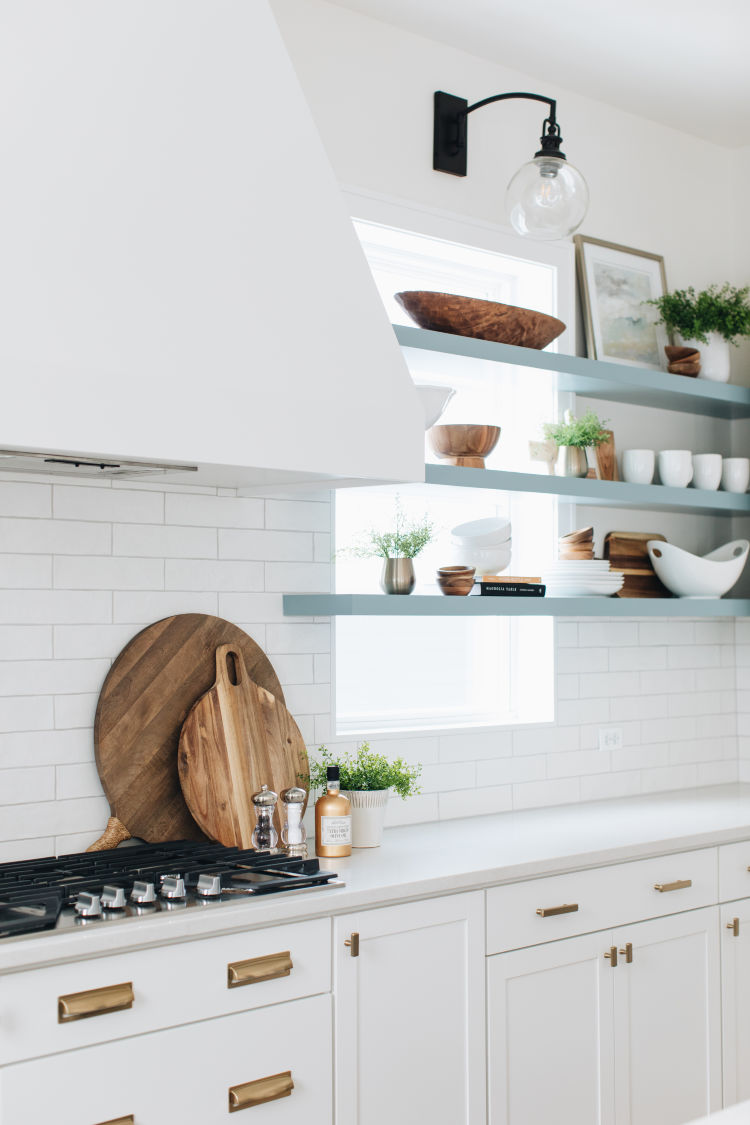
[{"xmin": 89, "ymin": 613, "xmax": 283, "ymax": 851}]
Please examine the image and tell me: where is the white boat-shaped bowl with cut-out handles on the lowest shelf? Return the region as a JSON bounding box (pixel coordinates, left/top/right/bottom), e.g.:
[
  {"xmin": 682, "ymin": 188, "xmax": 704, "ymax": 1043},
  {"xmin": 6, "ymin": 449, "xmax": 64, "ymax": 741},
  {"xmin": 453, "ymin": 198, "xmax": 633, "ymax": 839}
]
[{"xmin": 647, "ymin": 539, "xmax": 750, "ymax": 597}]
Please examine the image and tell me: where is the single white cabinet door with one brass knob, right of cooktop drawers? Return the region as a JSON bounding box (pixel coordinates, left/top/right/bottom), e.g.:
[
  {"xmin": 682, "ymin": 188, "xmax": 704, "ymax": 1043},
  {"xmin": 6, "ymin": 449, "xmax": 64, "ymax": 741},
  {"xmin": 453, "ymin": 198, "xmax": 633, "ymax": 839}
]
[{"xmin": 334, "ymin": 892, "xmax": 487, "ymax": 1125}]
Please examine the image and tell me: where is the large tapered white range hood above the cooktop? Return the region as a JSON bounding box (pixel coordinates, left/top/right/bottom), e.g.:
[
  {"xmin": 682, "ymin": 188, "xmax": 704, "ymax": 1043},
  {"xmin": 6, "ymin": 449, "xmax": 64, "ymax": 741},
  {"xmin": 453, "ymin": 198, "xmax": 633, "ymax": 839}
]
[{"xmin": 0, "ymin": 0, "xmax": 424, "ymax": 486}]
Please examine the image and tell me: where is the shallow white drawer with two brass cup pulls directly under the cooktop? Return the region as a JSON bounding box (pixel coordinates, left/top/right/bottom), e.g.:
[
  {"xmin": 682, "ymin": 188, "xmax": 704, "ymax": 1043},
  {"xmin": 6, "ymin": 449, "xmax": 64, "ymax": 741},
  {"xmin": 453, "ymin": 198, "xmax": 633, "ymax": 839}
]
[{"xmin": 0, "ymin": 918, "xmax": 331, "ymax": 1063}]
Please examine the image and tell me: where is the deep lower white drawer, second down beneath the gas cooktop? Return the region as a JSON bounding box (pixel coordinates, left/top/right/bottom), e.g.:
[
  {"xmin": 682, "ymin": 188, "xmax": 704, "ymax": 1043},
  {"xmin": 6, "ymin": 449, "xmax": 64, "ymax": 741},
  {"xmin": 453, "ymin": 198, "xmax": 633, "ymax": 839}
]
[{"xmin": 0, "ymin": 996, "xmax": 332, "ymax": 1125}]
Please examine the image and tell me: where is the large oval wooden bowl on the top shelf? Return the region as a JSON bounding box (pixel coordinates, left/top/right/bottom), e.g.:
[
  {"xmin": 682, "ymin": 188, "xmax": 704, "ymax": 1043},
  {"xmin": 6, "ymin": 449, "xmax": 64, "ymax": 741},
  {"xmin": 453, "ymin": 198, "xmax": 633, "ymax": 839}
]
[{"xmin": 396, "ymin": 289, "xmax": 566, "ymax": 350}]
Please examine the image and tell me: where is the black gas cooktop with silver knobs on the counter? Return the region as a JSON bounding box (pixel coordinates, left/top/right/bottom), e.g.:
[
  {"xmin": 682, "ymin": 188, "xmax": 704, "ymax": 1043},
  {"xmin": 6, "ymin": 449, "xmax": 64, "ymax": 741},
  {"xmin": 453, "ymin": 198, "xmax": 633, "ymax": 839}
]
[{"xmin": 0, "ymin": 840, "xmax": 343, "ymax": 938}]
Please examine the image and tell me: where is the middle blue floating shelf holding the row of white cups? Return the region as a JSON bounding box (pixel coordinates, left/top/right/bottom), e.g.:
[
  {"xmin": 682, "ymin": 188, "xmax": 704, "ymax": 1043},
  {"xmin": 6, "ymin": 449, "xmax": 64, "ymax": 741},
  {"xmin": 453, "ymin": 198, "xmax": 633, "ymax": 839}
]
[{"xmin": 425, "ymin": 465, "xmax": 750, "ymax": 515}]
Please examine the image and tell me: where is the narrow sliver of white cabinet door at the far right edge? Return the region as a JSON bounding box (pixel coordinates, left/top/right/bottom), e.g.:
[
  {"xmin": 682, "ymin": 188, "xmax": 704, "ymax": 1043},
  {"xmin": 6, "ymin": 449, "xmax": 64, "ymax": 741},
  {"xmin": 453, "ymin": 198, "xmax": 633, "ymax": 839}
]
[{"xmin": 720, "ymin": 899, "xmax": 750, "ymax": 1106}]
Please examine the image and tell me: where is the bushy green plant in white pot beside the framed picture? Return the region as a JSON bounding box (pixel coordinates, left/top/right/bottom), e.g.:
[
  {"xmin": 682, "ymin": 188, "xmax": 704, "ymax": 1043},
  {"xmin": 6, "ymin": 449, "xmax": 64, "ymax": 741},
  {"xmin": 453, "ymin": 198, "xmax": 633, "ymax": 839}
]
[{"xmin": 649, "ymin": 282, "xmax": 750, "ymax": 383}]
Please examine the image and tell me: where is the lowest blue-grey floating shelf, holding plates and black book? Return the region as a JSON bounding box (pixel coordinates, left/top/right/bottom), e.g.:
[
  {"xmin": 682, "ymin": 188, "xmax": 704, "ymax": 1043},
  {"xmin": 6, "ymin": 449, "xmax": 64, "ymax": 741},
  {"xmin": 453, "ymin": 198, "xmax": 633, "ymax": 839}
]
[{"xmin": 283, "ymin": 594, "xmax": 750, "ymax": 618}]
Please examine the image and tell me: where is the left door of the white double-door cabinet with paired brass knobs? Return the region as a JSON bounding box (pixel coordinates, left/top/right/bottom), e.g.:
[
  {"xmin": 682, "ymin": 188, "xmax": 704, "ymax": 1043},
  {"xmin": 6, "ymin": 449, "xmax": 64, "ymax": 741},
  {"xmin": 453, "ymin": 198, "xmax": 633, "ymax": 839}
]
[{"xmin": 487, "ymin": 934, "xmax": 614, "ymax": 1125}]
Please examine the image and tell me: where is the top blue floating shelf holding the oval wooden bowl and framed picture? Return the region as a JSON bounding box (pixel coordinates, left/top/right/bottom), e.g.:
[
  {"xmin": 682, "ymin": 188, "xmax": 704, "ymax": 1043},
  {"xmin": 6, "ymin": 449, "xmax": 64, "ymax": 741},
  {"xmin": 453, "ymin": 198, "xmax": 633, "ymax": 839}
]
[{"xmin": 394, "ymin": 324, "xmax": 750, "ymax": 419}]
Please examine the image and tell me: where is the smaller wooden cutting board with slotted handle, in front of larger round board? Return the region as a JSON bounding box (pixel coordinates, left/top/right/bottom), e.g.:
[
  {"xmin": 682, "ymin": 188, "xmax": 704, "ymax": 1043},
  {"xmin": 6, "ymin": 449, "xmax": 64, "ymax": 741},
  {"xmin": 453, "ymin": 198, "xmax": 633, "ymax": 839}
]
[{"xmin": 178, "ymin": 645, "xmax": 309, "ymax": 848}]
